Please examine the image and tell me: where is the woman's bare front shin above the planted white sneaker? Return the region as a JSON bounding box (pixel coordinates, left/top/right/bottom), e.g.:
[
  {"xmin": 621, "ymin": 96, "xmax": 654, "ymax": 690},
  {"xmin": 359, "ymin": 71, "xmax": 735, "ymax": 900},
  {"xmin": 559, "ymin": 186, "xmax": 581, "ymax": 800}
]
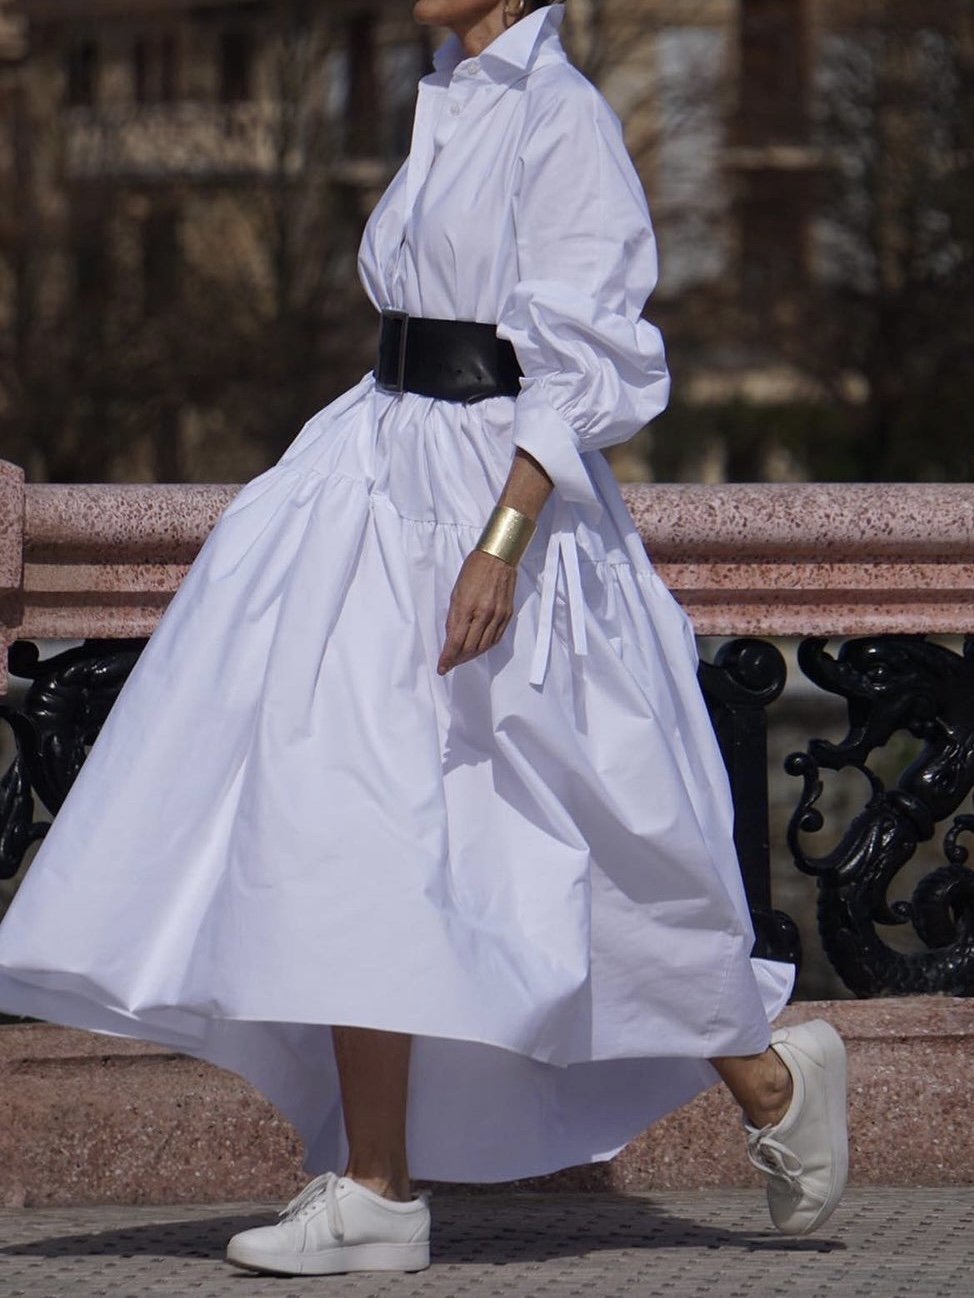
[{"xmin": 331, "ymin": 1028, "xmax": 413, "ymax": 1202}]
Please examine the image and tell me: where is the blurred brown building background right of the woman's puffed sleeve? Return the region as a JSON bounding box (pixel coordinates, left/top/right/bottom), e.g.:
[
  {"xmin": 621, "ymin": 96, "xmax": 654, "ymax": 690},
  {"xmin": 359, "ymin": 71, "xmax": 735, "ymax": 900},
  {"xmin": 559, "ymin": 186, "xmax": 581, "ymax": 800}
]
[{"xmin": 579, "ymin": 0, "xmax": 974, "ymax": 478}]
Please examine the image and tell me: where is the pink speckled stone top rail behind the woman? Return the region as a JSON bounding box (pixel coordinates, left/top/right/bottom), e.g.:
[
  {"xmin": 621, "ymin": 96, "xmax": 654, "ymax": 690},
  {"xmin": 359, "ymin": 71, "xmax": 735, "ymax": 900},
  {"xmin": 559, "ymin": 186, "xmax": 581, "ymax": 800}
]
[{"xmin": 0, "ymin": 461, "xmax": 974, "ymax": 685}]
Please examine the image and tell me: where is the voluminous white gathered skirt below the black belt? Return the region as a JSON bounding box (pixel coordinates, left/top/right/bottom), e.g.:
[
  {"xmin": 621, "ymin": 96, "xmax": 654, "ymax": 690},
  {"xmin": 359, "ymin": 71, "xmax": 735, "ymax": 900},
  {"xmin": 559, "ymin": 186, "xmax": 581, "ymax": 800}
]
[{"xmin": 0, "ymin": 376, "xmax": 793, "ymax": 1181}]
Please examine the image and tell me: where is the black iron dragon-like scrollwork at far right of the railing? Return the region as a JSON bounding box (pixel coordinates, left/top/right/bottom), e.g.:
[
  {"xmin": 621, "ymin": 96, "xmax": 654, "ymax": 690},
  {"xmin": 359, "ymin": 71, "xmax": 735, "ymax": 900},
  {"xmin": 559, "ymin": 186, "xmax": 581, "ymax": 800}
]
[{"xmin": 786, "ymin": 636, "xmax": 974, "ymax": 996}]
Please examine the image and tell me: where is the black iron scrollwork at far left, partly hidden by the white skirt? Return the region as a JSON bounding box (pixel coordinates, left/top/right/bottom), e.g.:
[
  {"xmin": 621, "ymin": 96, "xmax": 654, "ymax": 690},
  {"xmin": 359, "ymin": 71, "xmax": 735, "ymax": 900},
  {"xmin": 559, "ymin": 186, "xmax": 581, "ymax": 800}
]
[{"xmin": 0, "ymin": 637, "xmax": 145, "ymax": 879}]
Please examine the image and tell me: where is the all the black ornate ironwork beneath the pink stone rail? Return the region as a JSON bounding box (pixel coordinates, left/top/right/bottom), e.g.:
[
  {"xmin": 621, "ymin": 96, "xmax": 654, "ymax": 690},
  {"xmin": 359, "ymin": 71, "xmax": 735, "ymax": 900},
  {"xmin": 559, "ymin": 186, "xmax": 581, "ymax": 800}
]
[{"xmin": 0, "ymin": 635, "xmax": 974, "ymax": 997}]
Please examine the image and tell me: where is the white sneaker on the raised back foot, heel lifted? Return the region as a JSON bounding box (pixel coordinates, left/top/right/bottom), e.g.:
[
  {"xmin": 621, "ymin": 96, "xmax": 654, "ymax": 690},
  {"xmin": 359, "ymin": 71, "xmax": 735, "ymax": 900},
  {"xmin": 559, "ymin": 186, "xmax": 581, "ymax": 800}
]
[{"xmin": 744, "ymin": 1019, "xmax": 849, "ymax": 1234}]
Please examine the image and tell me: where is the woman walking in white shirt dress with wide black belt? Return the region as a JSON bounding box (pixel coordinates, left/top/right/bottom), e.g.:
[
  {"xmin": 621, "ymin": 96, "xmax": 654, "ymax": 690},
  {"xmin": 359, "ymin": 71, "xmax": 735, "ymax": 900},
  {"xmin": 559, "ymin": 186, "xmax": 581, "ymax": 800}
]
[{"xmin": 0, "ymin": 0, "xmax": 845, "ymax": 1273}]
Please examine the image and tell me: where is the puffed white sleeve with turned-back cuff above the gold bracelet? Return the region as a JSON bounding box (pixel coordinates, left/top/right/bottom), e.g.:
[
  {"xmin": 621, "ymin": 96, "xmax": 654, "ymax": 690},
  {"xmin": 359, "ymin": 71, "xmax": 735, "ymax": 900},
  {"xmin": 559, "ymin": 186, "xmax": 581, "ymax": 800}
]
[{"xmin": 497, "ymin": 75, "xmax": 670, "ymax": 517}]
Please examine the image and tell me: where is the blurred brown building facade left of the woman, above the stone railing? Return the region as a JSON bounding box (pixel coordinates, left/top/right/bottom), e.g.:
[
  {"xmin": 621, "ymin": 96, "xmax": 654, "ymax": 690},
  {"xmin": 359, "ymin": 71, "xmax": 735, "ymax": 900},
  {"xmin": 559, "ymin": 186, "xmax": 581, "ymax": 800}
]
[{"xmin": 0, "ymin": 0, "xmax": 430, "ymax": 479}]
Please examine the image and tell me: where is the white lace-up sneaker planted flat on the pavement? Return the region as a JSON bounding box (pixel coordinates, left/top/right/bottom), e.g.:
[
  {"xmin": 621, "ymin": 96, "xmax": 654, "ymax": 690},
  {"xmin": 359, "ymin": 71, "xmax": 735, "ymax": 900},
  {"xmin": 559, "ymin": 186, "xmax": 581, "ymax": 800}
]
[{"xmin": 226, "ymin": 1172, "xmax": 430, "ymax": 1276}]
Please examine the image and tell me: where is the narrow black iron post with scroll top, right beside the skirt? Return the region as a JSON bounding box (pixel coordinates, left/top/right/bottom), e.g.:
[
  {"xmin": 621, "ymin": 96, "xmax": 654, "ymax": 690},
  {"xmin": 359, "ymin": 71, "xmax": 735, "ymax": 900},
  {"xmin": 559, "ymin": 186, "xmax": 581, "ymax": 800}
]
[{"xmin": 699, "ymin": 639, "xmax": 801, "ymax": 966}]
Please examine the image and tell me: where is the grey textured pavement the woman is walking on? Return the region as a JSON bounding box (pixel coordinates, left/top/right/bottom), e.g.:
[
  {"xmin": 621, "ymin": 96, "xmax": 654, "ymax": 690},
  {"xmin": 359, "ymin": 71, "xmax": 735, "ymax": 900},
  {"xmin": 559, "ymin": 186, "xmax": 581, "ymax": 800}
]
[{"xmin": 0, "ymin": 1188, "xmax": 974, "ymax": 1298}]
